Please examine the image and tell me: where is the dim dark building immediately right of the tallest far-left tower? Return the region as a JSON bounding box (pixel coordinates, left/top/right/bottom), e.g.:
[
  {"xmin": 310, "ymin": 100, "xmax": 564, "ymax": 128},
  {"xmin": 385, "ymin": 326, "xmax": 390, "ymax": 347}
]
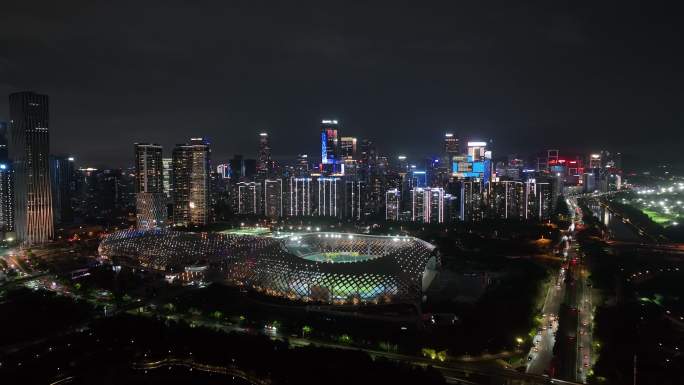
[{"xmin": 50, "ymin": 156, "xmax": 76, "ymax": 223}]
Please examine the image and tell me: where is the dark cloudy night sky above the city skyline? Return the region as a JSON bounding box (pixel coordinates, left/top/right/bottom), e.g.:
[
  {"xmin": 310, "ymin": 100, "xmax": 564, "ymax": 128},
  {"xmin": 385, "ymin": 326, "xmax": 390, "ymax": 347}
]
[{"xmin": 0, "ymin": 0, "xmax": 684, "ymax": 166}]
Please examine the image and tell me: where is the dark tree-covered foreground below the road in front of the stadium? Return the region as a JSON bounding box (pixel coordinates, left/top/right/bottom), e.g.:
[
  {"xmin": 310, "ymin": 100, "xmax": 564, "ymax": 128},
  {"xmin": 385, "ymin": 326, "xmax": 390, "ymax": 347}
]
[{"xmin": 0, "ymin": 292, "xmax": 444, "ymax": 384}]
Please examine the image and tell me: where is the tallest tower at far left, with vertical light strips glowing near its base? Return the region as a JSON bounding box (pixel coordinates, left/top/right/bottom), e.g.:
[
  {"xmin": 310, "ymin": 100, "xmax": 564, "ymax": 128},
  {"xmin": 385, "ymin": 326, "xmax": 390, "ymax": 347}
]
[{"xmin": 9, "ymin": 92, "xmax": 54, "ymax": 244}]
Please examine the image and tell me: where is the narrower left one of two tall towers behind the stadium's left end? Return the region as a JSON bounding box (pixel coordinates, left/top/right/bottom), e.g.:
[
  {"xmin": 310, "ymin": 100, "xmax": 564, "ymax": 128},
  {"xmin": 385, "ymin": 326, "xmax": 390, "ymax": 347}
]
[{"xmin": 134, "ymin": 143, "xmax": 167, "ymax": 229}]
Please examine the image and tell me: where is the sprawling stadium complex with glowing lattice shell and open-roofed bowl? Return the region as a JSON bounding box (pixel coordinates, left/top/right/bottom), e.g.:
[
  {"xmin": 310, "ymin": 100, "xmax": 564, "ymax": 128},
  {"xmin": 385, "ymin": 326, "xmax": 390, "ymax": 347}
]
[{"xmin": 99, "ymin": 230, "xmax": 439, "ymax": 304}]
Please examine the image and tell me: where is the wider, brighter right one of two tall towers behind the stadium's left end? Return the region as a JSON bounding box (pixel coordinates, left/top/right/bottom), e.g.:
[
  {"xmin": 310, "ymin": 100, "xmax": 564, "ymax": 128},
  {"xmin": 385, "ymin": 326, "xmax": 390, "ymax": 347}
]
[{"xmin": 172, "ymin": 138, "xmax": 211, "ymax": 225}]
